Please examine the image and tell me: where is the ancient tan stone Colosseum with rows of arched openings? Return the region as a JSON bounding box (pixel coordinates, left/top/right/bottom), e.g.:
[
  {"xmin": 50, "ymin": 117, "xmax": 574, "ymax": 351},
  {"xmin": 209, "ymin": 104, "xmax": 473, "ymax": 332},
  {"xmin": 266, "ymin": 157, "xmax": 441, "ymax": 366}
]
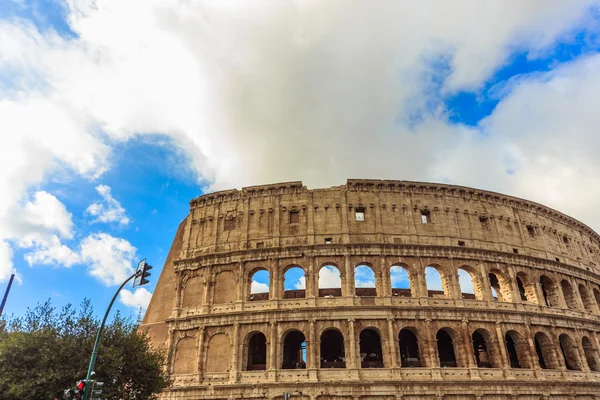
[{"xmin": 142, "ymin": 179, "xmax": 600, "ymax": 400}]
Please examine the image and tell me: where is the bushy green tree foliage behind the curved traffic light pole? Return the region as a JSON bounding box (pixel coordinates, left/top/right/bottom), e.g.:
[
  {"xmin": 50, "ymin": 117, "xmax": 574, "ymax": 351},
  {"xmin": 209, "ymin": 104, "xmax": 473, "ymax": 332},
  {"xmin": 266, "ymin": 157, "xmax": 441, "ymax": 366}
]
[{"xmin": 0, "ymin": 300, "xmax": 169, "ymax": 400}]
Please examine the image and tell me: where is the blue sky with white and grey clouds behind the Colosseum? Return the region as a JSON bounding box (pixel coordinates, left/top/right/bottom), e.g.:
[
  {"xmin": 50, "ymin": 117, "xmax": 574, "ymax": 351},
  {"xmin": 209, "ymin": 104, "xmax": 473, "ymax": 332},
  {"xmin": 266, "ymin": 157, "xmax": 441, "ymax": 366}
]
[{"xmin": 0, "ymin": 0, "xmax": 600, "ymax": 317}]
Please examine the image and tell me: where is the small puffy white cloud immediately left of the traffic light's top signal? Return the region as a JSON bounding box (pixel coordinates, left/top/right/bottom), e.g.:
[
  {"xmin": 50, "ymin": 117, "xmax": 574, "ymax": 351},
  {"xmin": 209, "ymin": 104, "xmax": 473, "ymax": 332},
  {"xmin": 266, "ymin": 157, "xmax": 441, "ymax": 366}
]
[{"xmin": 80, "ymin": 233, "xmax": 136, "ymax": 285}]
